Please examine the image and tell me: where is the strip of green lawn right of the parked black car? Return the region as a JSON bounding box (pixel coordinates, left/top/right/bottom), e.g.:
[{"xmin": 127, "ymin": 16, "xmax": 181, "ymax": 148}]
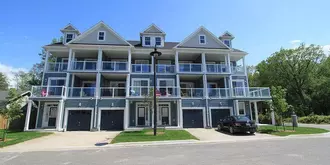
[{"xmin": 258, "ymin": 126, "xmax": 329, "ymax": 136}]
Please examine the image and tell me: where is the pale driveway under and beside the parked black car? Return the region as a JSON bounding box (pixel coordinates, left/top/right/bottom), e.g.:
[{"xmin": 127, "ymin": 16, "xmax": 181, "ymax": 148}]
[{"xmin": 186, "ymin": 128, "xmax": 278, "ymax": 141}]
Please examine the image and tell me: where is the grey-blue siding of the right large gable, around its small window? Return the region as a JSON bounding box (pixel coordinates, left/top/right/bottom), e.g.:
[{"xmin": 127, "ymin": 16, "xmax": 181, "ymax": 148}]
[{"xmin": 180, "ymin": 30, "xmax": 226, "ymax": 49}]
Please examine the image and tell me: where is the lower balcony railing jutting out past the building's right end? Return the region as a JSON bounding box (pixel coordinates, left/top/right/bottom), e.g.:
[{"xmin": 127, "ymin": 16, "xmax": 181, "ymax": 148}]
[{"xmin": 233, "ymin": 87, "xmax": 271, "ymax": 98}]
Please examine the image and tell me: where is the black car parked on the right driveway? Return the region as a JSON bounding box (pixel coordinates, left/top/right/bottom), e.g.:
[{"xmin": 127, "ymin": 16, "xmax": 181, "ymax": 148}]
[{"xmin": 218, "ymin": 116, "xmax": 257, "ymax": 134}]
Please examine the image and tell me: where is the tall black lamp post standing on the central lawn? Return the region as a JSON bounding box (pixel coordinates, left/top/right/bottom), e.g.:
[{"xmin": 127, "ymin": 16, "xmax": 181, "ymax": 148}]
[{"xmin": 150, "ymin": 44, "xmax": 162, "ymax": 136}]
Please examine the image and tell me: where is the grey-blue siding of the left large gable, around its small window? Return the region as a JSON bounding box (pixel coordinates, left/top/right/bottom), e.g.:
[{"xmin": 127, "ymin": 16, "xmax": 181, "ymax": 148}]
[{"xmin": 74, "ymin": 25, "xmax": 127, "ymax": 45}]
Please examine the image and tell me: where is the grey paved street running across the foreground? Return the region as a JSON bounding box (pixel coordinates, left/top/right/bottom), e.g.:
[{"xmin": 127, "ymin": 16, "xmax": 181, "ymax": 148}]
[{"xmin": 0, "ymin": 137, "xmax": 330, "ymax": 165}]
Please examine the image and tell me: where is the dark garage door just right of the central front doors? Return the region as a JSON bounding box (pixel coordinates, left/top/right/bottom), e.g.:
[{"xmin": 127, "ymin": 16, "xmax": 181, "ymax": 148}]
[{"xmin": 183, "ymin": 109, "xmax": 204, "ymax": 128}]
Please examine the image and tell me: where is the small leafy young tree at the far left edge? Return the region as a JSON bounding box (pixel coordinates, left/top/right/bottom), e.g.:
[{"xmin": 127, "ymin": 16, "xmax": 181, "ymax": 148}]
[{"xmin": 0, "ymin": 88, "xmax": 23, "ymax": 141}]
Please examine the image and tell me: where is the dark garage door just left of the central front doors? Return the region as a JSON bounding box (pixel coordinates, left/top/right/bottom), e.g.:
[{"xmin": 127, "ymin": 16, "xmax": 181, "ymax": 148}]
[{"xmin": 101, "ymin": 110, "xmax": 124, "ymax": 130}]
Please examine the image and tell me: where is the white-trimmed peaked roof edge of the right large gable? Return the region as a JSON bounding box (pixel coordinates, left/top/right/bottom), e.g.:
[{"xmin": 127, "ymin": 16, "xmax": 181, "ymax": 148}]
[{"xmin": 175, "ymin": 26, "xmax": 231, "ymax": 49}]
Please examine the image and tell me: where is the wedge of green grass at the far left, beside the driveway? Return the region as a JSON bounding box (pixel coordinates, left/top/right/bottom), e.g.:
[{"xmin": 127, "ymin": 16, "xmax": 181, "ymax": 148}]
[{"xmin": 0, "ymin": 130, "xmax": 52, "ymax": 148}]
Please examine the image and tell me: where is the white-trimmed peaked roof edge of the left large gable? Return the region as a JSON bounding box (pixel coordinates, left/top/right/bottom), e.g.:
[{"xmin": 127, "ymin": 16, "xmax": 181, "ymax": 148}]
[{"xmin": 66, "ymin": 21, "xmax": 132, "ymax": 46}]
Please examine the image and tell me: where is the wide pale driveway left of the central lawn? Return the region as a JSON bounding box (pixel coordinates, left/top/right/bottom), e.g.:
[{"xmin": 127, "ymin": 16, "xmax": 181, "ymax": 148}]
[{"xmin": 0, "ymin": 131, "xmax": 120, "ymax": 151}]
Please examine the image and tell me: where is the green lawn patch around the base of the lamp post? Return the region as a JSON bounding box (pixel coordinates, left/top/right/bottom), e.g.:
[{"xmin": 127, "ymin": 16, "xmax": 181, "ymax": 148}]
[{"xmin": 111, "ymin": 129, "xmax": 198, "ymax": 143}]
